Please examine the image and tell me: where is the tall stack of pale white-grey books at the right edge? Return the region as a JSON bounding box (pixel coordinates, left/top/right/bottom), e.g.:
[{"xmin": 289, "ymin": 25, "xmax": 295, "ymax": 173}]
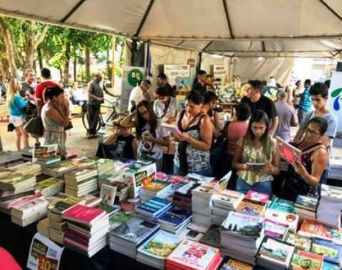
[{"xmin": 317, "ymin": 184, "xmax": 342, "ymax": 228}]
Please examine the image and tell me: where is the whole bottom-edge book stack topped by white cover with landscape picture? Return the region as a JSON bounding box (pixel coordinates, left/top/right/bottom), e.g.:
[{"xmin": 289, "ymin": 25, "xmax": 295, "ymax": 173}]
[{"xmin": 257, "ymin": 237, "xmax": 295, "ymax": 270}]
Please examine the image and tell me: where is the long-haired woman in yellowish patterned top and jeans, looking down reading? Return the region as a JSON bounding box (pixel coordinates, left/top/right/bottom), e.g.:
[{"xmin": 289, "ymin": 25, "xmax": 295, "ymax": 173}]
[{"xmin": 232, "ymin": 110, "xmax": 280, "ymax": 197}]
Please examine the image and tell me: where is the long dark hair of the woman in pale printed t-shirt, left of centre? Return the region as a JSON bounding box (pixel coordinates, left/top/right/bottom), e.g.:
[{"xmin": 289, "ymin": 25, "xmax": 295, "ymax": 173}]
[{"xmin": 135, "ymin": 100, "xmax": 158, "ymax": 139}]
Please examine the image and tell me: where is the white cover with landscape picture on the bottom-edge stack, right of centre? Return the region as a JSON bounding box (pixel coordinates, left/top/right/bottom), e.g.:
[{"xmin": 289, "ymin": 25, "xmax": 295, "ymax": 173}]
[{"xmin": 258, "ymin": 238, "xmax": 295, "ymax": 267}]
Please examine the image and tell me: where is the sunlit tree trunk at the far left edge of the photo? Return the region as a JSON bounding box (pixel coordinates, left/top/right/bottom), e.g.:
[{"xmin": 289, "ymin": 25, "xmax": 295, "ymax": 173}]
[{"xmin": 0, "ymin": 17, "xmax": 18, "ymax": 78}]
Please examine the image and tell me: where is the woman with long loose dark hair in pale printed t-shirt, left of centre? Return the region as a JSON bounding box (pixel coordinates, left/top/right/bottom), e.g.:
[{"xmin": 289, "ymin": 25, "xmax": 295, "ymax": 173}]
[{"xmin": 120, "ymin": 100, "xmax": 170, "ymax": 170}]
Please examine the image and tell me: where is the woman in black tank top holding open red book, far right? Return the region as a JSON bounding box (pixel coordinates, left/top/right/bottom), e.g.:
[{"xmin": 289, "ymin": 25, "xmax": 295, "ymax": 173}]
[{"xmin": 282, "ymin": 117, "xmax": 329, "ymax": 201}]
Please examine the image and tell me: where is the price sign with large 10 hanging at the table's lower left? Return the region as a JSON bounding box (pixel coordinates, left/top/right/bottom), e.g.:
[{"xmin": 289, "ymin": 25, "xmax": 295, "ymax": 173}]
[{"xmin": 26, "ymin": 233, "xmax": 64, "ymax": 270}]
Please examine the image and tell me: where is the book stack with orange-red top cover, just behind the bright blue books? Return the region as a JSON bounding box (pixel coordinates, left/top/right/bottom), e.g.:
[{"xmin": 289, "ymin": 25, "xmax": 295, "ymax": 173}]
[{"xmin": 140, "ymin": 180, "xmax": 172, "ymax": 202}]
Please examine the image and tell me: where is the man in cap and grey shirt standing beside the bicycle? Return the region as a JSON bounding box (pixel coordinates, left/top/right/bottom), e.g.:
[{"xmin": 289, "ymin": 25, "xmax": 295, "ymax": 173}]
[{"xmin": 87, "ymin": 72, "xmax": 104, "ymax": 137}]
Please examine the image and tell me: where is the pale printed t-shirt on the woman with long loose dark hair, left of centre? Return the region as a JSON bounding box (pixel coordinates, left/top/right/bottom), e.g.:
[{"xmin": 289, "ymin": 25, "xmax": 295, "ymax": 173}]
[{"xmin": 138, "ymin": 120, "xmax": 168, "ymax": 160}]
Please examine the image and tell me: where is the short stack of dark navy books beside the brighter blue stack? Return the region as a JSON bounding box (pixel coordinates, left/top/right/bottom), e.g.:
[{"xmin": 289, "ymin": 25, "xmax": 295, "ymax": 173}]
[{"xmin": 158, "ymin": 207, "xmax": 192, "ymax": 234}]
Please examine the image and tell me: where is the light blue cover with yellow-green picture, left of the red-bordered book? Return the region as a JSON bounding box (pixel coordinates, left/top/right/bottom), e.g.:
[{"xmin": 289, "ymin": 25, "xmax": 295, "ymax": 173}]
[{"xmin": 138, "ymin": 230, "xmax": 181, "ymax": 259}]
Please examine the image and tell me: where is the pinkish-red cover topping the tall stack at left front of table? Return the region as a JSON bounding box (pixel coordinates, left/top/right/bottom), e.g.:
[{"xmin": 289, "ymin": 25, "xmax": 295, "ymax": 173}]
[{"xmin": 63, "ymin": 204, "xmax": 106, "ymax": 224}]
